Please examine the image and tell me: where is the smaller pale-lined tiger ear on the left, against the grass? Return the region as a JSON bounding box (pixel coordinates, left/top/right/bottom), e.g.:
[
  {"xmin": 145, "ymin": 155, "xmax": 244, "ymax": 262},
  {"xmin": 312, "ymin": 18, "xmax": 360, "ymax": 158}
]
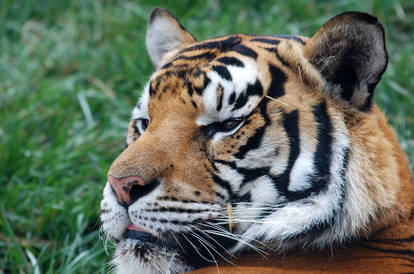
[{"xmin": 145, "ymin": 8, "xmax": 197, "ymax": 69}]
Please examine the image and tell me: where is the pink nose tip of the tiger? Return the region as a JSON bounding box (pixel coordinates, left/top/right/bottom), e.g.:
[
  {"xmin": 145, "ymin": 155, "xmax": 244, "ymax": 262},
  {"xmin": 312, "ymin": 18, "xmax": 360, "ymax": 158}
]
[{"xmin": 108, "ymin": 175, "xmax": 145, "ymax": 205}]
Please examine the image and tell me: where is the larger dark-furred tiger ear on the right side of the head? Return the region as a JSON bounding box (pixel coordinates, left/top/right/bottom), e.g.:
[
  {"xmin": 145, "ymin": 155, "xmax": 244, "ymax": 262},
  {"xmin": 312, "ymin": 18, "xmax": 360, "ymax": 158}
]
[{"xmin": 304, "ymin": 12, "xmax": 388, "ymax": 111}]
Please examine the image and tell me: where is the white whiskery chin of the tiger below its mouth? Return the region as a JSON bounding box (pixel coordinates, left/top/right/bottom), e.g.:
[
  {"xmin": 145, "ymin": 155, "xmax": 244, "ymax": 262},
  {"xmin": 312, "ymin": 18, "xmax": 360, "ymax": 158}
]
[{"xmin": 112, "ymin": 235, "xmax": 195, "ymax": 274}]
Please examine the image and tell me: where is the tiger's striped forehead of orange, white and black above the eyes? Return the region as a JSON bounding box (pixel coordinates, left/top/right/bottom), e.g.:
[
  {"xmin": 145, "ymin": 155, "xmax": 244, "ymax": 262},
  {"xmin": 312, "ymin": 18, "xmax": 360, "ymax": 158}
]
[{"xmin": 133, "ymin": 35, "xmax": 304, "ymax": 122}]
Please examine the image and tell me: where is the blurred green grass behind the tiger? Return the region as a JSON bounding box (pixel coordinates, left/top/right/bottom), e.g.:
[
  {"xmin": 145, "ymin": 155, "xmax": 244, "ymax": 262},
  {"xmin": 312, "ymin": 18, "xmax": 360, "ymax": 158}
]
[{"xmin": 0, "ymin": 0, "xmax": 414, "ymax": 273}]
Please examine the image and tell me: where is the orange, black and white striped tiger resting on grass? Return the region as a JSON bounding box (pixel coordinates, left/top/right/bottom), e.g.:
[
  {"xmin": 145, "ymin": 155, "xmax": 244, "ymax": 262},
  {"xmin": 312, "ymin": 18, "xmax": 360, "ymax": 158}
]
[{"xmin": 100, "ymin": 8, "xmax": 414, "ymax": 273}]
